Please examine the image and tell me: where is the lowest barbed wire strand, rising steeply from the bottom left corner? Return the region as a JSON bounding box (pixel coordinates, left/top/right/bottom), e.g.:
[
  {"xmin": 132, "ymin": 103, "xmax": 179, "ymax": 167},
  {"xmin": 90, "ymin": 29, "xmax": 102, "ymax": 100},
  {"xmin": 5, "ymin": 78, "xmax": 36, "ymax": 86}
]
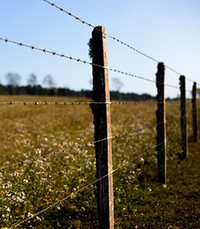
[{"xmin": 11, "ymin": 142, "xmax": 164, "ymax": 228}]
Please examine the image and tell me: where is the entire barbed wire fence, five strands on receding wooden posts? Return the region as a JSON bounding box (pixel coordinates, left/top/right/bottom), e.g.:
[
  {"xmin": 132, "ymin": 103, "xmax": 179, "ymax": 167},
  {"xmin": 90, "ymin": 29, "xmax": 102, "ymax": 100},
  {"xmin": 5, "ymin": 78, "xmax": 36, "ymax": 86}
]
[{"xmin": 0, "ymin": 0, "xmax": 199, "ymax": 228}]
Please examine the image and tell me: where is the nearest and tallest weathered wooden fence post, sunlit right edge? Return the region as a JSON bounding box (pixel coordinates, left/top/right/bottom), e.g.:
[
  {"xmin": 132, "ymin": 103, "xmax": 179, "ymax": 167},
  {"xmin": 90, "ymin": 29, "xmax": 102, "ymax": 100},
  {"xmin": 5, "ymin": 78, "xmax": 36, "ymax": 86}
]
[{"xmin": 89, "ymin": 26, "xmax": 114, "ymax": 229}]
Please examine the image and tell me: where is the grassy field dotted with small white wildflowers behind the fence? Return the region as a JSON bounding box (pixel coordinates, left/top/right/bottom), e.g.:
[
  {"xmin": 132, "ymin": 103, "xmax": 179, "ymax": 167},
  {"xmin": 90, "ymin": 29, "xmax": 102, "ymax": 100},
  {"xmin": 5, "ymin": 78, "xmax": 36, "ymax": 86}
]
[{"xmin": 0, "ymin": 96, "xmax": 200, "ymax": 229}]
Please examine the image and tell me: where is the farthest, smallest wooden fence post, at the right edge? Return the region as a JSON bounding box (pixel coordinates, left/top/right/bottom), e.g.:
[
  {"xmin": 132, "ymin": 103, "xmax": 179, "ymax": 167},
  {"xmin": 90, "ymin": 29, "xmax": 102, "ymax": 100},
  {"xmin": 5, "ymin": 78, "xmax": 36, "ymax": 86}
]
[{"xmin": 192, "ymin": 82, "xmax": 198, "ymax": 142}]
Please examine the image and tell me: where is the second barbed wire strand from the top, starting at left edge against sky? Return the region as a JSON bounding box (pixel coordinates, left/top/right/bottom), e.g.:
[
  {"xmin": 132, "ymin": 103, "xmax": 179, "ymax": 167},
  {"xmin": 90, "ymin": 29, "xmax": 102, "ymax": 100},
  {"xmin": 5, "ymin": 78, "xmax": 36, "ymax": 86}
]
[{"xmin": 0, "ymin": 37, "xmax": 191, "ymax": 92}]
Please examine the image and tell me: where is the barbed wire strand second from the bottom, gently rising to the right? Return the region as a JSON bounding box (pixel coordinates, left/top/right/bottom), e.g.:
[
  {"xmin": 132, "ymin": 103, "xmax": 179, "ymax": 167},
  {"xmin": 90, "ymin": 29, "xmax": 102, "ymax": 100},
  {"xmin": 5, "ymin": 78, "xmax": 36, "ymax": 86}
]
[{"xmin": 0, "ymin": 122, "xmax": 163, "ymax": 170}]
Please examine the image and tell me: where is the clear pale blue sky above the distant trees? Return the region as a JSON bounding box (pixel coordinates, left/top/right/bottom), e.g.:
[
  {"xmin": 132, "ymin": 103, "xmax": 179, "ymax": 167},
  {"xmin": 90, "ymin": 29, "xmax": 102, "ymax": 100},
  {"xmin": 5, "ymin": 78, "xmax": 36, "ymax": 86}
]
[{"xmin": 0, "ymin": 0, "xmax": 200, "ymax": 97}]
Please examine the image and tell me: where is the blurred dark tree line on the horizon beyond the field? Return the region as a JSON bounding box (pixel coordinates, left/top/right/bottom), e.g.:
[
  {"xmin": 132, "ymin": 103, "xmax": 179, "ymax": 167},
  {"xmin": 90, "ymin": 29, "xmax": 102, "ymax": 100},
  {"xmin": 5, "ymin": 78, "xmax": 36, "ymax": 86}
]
[{"xmin": 0, "ymin": 73, "xmax": 200, "ymax": 101}]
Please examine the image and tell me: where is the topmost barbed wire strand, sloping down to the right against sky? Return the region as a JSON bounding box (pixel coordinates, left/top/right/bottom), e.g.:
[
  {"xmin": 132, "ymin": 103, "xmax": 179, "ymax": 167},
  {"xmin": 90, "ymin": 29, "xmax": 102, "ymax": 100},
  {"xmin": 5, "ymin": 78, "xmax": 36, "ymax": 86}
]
[{"xmin": 43, "ymin": 0, "xmax": 200, "ymax": 85}]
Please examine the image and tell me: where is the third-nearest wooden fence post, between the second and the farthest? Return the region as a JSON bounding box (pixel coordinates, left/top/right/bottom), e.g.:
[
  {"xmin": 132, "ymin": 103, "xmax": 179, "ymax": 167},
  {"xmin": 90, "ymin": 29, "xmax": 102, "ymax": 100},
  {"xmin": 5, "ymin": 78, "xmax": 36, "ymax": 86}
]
[{"xmin": 179, "ymin": 76, "xmax": 188, "ymax": 158}]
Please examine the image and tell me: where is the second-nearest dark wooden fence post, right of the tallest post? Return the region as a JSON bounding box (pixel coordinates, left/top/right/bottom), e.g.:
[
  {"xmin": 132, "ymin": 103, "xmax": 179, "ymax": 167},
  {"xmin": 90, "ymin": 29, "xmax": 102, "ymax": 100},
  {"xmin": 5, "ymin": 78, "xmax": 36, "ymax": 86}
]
[{"xmin": 156, "ymin": 63, "xmax": 167, "ymax": 184}]
